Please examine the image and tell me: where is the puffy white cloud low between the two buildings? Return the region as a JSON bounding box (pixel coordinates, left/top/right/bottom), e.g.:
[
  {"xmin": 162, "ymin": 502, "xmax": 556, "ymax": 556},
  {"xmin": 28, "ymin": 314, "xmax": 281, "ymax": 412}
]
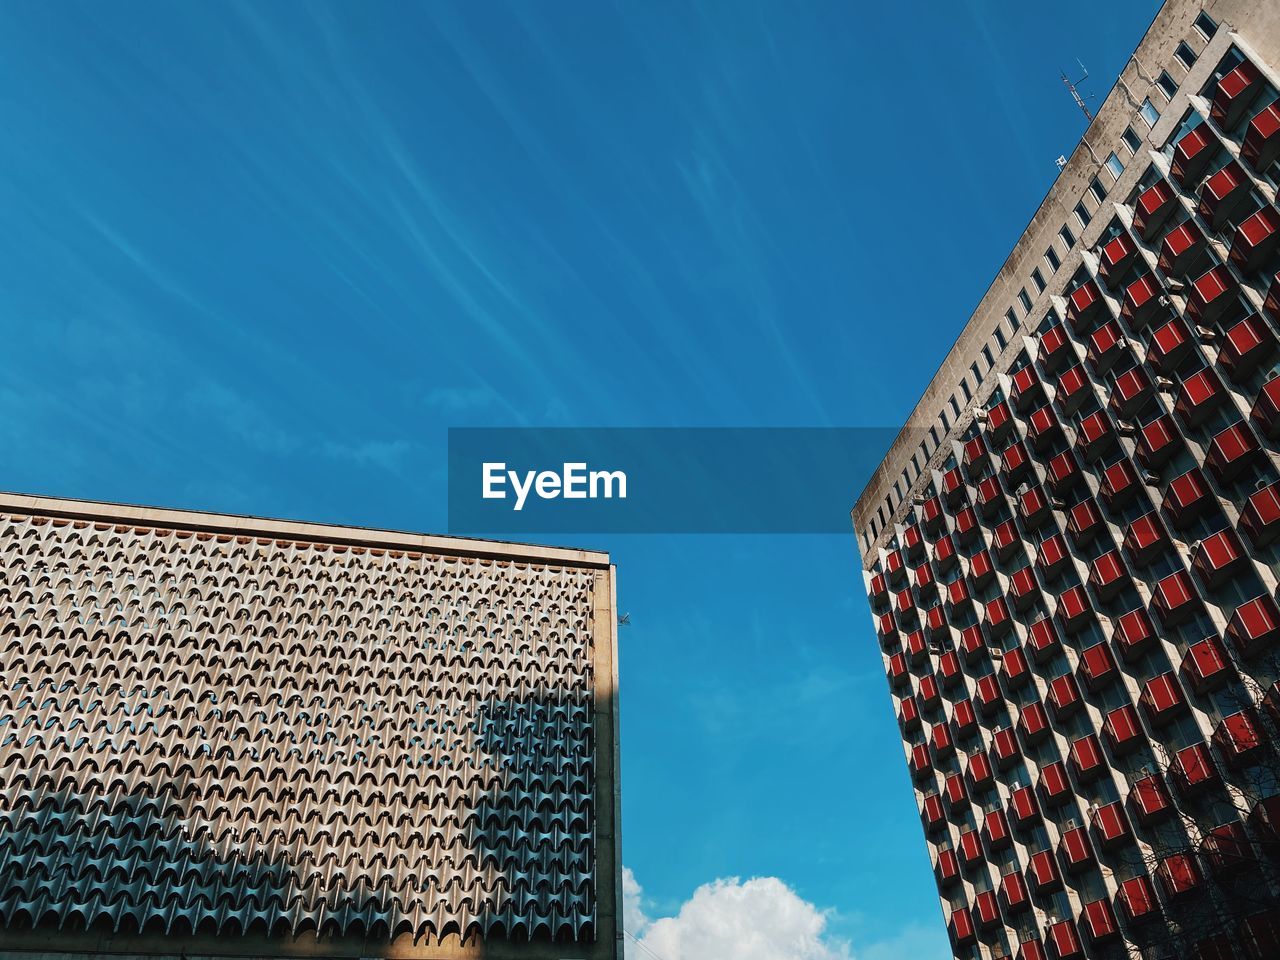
[{"xmin": 622, "ymin": 868, "xmax": 850, "ymax": 960}]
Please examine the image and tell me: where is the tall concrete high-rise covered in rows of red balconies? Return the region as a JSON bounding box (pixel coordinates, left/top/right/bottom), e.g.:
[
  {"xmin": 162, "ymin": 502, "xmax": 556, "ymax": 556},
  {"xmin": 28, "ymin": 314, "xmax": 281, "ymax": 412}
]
[{"xmin": 854, "ymin": 0, "xmax": 1280, "ymax": 960}]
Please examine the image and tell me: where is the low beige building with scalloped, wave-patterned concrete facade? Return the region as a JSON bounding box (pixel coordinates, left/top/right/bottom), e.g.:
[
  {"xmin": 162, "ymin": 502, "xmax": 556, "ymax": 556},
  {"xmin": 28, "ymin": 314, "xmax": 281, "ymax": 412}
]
[{"xmin": 0, "ymin": 494, "xmax": 622, "ymax": 960}]
